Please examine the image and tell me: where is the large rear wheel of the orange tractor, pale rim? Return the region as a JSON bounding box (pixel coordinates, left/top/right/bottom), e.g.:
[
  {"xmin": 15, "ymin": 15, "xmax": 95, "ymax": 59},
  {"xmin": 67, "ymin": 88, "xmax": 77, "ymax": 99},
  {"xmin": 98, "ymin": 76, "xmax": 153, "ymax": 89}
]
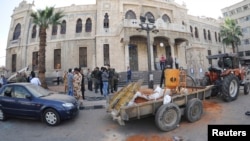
[{"xmin": 221, "ymin": 74, "xmax": 240, "ymax": 102}]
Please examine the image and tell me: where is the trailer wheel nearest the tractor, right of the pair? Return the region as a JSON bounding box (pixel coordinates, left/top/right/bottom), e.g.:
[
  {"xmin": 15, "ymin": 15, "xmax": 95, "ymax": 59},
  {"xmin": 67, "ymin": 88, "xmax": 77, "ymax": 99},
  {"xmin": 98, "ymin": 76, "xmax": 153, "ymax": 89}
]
[{"xmin": 184, "ymin": 98, "xmax": 203, "ymax": 122}]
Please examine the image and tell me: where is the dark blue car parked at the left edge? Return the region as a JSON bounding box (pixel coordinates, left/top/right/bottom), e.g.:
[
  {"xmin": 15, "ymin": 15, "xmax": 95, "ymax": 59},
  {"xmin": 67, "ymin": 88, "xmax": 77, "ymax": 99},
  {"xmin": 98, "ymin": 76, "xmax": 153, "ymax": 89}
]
[{"xmin": 0, "ymin": 83, "xmax": 79, "ymax": 126}]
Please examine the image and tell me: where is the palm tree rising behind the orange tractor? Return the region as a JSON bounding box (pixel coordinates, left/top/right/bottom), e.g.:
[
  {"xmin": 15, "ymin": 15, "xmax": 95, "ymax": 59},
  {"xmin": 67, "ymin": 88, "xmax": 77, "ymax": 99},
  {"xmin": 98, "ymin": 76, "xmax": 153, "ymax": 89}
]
[{"xmin": 220, "ymin": 17, "xmax": 243, "ymax": 53}]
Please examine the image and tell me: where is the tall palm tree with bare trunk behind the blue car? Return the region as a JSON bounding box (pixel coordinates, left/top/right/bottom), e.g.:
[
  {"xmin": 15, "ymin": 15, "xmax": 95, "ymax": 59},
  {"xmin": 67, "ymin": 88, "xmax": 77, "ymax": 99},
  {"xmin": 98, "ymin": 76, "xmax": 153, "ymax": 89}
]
[{"xmin": 30, "ymin": 6, "xmax": 64, "ymax": 88}]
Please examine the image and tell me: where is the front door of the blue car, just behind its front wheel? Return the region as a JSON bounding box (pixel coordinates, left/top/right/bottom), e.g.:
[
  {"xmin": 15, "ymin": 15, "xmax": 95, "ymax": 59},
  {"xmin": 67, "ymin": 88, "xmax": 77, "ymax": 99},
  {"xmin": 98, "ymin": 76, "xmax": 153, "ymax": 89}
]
[{"xmin": 13, "ymin": 86, "xmax": 42, "ymax": 117}]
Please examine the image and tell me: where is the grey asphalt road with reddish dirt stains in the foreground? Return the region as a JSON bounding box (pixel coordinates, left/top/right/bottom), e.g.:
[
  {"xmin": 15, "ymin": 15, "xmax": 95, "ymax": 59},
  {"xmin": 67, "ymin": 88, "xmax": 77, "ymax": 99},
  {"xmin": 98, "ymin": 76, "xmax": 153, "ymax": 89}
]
[{"xmin": 0, "ymin": 90, "xmax": 250, "ymax": 141}]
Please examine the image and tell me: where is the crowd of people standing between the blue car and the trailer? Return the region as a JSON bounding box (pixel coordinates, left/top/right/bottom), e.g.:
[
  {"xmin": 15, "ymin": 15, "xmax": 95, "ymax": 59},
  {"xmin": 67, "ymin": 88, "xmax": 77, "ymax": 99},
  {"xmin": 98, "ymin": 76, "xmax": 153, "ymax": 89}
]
[{"xmin": 59, "ymin": 65, "xmax": 119, "ymax": 107}]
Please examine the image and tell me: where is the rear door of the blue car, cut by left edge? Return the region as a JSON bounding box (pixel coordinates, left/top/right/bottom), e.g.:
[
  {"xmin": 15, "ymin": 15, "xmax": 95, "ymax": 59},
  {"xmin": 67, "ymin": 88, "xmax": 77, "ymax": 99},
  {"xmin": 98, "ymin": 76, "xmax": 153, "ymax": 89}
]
[{"xmin": 0, "ymin": 86, "xmax": 18, "ymax": 115}]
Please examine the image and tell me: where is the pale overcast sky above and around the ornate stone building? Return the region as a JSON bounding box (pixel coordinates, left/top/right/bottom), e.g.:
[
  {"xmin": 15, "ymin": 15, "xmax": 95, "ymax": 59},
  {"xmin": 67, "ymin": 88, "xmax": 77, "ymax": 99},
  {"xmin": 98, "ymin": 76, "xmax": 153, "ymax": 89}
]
[{"xmin": 0, "ymin": 0, "xmax": 243, "ymax": 66}]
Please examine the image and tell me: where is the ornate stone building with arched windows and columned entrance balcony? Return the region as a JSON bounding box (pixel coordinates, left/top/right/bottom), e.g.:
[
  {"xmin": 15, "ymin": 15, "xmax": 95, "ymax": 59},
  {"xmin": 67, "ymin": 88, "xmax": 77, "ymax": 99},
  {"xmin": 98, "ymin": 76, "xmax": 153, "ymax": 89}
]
[{"xmin": 6, "ymin": 0, "xmax": 230, "ymax": 77}]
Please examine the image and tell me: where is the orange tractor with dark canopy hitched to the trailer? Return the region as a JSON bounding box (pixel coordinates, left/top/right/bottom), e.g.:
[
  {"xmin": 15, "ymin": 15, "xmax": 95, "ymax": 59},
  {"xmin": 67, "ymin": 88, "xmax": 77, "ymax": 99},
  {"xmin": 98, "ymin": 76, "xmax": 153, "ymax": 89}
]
[{"xmin": 201, "ymin": 53, "xmax": 250, "ymax": 102}]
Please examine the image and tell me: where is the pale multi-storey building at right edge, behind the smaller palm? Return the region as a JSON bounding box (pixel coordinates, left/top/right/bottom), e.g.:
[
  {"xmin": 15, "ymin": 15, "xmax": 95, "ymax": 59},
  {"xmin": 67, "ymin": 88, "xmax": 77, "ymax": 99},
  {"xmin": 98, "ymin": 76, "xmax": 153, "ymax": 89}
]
[{"xmin": 221, "ymin": 0, "xmax": 250, "ymax": 64}]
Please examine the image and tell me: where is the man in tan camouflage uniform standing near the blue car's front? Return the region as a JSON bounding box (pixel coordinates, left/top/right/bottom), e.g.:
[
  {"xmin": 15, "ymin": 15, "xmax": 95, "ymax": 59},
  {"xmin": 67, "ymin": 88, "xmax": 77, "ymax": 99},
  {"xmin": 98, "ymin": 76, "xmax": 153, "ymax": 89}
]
[{"xmin": 73, "ymin": 68, "xmax": 83, "ymax": 107}]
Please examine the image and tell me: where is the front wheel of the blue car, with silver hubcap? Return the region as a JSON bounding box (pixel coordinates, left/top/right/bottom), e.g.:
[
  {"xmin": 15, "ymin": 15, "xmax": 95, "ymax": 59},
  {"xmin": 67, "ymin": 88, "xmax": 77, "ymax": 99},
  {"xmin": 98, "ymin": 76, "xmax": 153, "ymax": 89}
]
[{"xmin": 43, "ymin": 109, "xmax": 60, "ymax": 126}]
